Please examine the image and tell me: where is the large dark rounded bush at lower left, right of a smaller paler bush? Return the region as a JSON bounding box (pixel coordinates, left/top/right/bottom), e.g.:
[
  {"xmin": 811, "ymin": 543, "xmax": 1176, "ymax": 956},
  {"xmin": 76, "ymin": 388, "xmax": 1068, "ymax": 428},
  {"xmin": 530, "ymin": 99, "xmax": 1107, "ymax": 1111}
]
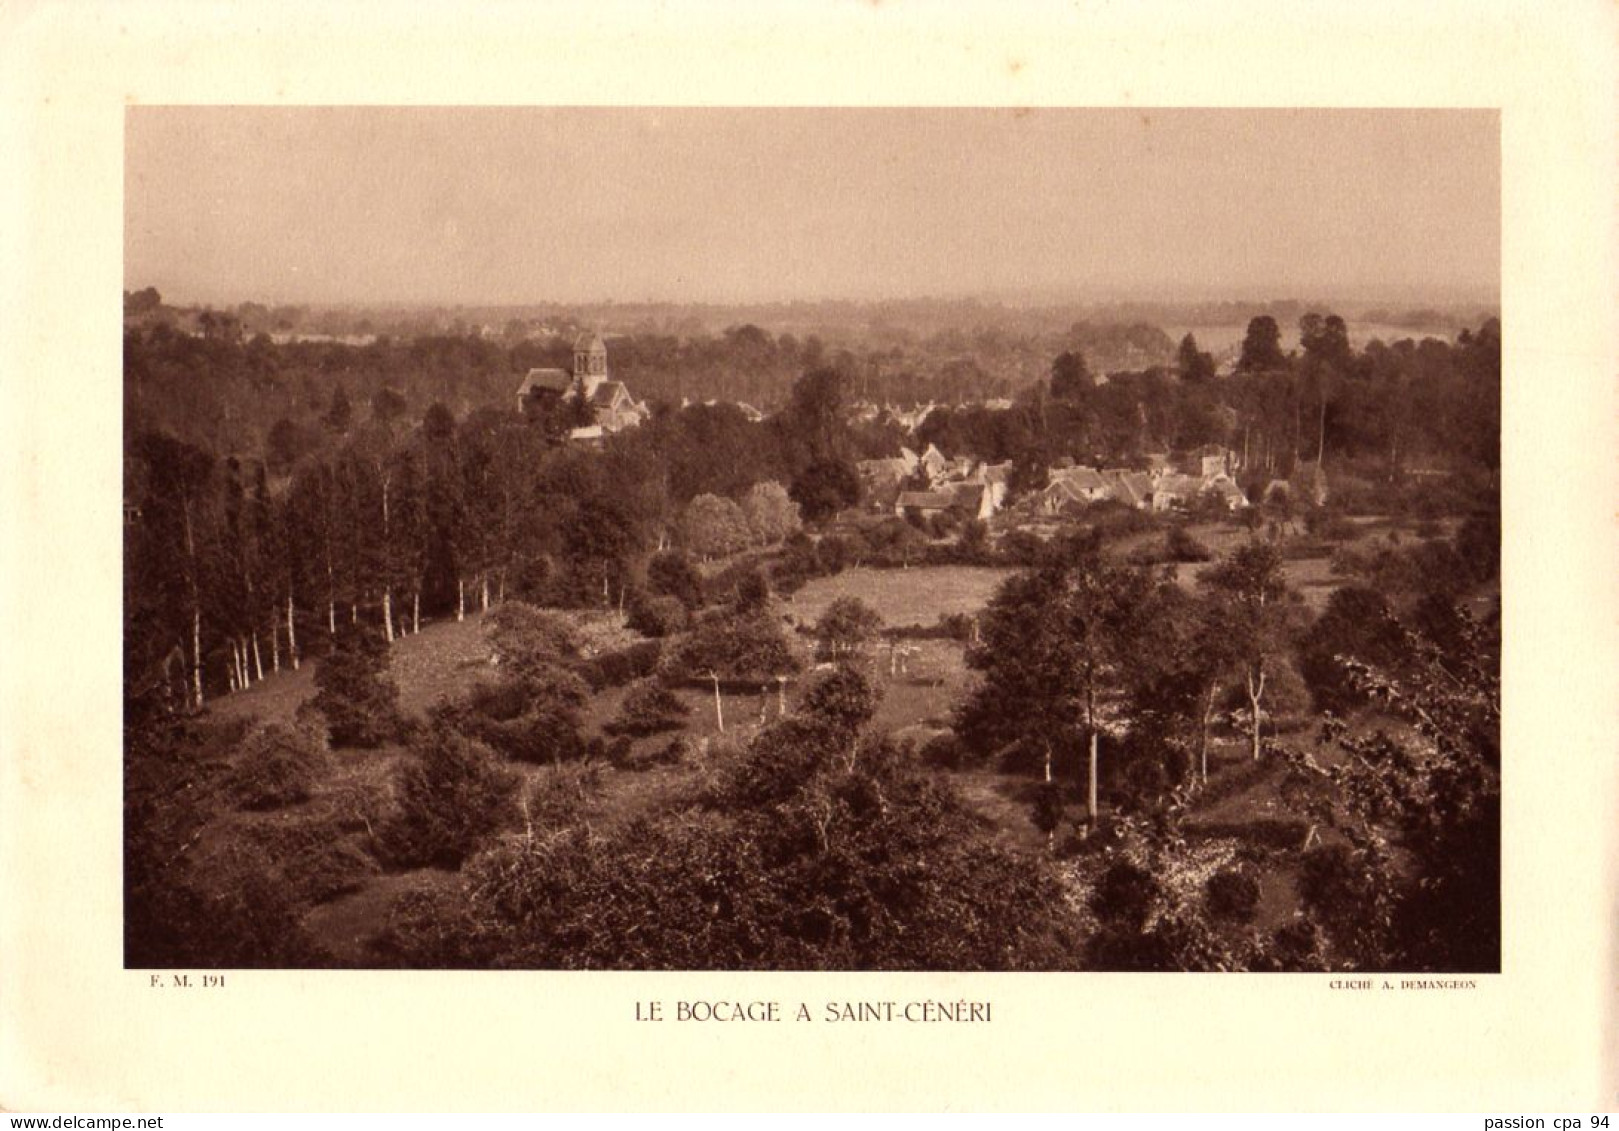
[{"xmin": 382, "ymin": 726, "xmax": 518, "ymax": 867}]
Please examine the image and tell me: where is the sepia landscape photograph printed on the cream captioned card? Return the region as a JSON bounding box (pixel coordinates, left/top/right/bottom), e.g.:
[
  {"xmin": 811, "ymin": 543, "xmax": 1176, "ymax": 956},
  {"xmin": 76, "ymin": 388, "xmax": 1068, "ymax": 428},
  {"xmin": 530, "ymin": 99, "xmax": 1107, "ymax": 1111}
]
[{"xmin": 123, "ymin": 105, "xmax": 1511, "ymax": 970}]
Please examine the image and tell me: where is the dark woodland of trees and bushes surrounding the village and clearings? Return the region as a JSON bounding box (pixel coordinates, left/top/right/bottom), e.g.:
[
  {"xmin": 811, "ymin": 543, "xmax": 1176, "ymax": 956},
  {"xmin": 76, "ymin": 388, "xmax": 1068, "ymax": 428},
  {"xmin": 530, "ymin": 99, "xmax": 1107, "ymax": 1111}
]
[{"xmin": 125, "ymin": 296, "xmax": 1501, "ymax": 969}]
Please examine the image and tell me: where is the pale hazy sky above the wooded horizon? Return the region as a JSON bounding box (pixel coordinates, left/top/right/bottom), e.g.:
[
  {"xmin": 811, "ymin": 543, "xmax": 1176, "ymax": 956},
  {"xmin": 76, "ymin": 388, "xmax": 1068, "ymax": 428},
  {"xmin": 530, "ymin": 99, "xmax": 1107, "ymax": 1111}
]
[{"xmin": 125, "ymin": 107, "xmax": 1501, "ymax": 304}]
